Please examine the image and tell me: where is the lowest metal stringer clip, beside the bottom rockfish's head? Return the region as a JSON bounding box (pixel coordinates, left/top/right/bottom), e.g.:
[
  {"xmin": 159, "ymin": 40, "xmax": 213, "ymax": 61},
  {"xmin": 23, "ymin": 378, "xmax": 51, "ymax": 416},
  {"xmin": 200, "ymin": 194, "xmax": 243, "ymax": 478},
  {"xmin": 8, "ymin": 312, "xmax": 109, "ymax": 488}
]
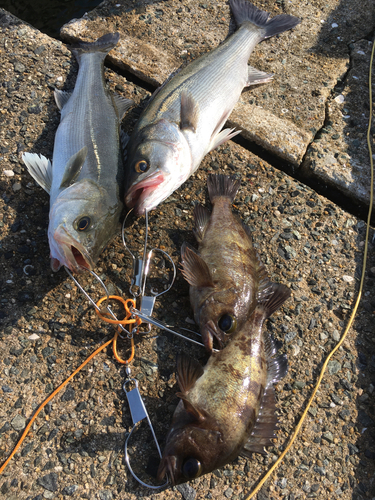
[{"xmin": 123, "ymin": 376, "xmax": 168, "ymax": 490}]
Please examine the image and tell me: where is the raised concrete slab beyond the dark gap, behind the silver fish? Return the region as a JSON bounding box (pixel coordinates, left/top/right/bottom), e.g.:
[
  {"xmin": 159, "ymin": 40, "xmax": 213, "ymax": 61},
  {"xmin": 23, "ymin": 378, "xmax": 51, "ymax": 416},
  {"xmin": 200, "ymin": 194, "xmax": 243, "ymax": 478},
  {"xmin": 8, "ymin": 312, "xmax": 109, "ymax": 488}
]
[{"xmin": 61, "ymin": 0, "xmax": 375, "ymax": 203}]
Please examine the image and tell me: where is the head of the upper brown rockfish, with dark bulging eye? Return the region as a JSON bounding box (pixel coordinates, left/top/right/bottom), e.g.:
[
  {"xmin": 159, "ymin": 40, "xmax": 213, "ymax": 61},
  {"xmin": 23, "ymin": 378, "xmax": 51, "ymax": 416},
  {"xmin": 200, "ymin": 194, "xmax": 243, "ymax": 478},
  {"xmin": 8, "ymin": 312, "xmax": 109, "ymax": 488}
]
[{"xmin": 191, "ymin": 288, "xmax": 251, "ymax": 351}]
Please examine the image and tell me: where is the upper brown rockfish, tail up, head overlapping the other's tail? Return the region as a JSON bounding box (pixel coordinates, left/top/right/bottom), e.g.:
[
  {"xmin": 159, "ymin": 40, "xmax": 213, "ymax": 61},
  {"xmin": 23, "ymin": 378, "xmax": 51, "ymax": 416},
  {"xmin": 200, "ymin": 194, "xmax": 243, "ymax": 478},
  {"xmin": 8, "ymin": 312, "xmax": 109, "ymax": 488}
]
[{"xmin": 181, "ymin": 175, "xmax": 284, "ymax": 351}]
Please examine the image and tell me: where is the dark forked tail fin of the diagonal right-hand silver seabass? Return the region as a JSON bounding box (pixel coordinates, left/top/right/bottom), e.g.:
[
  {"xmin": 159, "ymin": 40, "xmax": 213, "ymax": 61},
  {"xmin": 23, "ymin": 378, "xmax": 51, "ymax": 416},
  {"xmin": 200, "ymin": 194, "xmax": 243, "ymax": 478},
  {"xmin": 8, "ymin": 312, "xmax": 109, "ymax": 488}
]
[{"xmin": 230, "ymin": 0, "xmax": 301, "ymax": 40}]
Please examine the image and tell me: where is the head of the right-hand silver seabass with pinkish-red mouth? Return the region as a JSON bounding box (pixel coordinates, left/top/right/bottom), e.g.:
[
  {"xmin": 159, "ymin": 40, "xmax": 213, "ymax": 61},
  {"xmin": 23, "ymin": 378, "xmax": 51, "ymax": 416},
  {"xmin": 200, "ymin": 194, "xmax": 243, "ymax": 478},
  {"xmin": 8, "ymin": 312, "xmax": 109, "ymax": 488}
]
[{"xmin": 125, "ymin": 120, "xmax": 192, "ymax": 215}]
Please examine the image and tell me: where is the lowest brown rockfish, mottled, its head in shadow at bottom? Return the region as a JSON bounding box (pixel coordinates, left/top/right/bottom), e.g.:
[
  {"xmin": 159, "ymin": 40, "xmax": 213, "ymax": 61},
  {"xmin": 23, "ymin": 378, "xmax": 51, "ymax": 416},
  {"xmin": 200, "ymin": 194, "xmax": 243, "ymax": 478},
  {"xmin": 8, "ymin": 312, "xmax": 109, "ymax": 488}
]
[{"xmin": 158, "ymin": 284, "xmax": 290, "ymax": 484}]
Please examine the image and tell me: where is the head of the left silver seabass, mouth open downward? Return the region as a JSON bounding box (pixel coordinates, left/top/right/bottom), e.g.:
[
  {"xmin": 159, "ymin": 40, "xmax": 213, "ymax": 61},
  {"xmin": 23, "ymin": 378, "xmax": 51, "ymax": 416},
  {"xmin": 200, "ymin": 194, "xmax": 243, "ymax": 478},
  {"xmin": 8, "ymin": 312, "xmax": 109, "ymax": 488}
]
[{"xmin": 48, "ymin": 179, "xmax": 123, "ymax": 272}]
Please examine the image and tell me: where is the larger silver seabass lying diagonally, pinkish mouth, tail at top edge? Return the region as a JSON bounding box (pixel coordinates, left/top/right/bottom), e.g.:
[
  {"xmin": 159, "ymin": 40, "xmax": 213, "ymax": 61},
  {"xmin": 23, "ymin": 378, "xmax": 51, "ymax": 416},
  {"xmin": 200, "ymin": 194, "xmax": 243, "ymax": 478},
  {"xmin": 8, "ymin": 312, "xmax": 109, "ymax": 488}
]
[{"xmin": 125, "ymin": 0, "xmax": 300, "ymax": 215}]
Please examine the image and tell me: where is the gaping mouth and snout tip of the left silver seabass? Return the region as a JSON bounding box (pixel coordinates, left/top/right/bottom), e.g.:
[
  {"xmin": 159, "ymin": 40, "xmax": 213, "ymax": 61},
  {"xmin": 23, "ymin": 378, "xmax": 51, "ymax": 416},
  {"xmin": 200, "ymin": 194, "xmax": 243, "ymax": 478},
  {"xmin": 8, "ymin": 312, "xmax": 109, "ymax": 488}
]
[{"xmin": 50, "ymin": 226, "xmax": 94, "ymax": 272}]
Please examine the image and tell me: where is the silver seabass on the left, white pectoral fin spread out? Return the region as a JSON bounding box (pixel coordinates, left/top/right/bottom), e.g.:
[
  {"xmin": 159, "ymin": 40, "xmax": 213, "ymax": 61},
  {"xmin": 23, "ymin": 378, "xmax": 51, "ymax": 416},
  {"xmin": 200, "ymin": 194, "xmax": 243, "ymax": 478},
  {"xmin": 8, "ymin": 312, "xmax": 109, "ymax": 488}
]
[{"xmin": 22, "ymin": 33, "xmax": 132, "ymax": 271}]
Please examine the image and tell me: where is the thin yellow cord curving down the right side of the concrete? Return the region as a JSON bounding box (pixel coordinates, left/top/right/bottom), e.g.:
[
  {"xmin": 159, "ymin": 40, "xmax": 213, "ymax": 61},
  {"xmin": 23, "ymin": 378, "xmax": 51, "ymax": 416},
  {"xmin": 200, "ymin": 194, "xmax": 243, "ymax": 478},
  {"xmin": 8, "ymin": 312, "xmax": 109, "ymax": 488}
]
[{"xmin": 245, "ymin": 39, "xmax": 375, "ymax": 500}]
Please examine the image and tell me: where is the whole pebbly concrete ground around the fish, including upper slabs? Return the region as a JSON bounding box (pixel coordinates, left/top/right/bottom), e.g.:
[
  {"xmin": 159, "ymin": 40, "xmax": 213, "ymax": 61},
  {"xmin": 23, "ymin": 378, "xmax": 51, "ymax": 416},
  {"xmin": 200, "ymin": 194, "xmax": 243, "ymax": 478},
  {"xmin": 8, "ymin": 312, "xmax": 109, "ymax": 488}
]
[{"xmin": 0, "ymin": 0, "xmax": 375, "ymax": 500}]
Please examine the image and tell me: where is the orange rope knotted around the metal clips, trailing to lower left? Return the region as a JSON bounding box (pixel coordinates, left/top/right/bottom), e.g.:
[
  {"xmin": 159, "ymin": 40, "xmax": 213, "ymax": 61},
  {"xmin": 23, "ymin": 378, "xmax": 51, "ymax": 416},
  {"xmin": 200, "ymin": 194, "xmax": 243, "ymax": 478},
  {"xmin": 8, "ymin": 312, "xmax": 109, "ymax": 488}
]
[{"xmin": 0, "ymin": 295, "xmax": 142, "ymax": 474}]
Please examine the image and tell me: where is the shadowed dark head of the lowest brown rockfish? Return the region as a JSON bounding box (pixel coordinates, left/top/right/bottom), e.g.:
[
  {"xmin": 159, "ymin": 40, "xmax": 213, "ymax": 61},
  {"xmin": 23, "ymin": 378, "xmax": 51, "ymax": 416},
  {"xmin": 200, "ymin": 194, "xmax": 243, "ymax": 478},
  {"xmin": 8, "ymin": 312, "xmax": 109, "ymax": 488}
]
[{"xmin": 157, "ymin": 425, "xmax": 223, "ymax": 485}]
